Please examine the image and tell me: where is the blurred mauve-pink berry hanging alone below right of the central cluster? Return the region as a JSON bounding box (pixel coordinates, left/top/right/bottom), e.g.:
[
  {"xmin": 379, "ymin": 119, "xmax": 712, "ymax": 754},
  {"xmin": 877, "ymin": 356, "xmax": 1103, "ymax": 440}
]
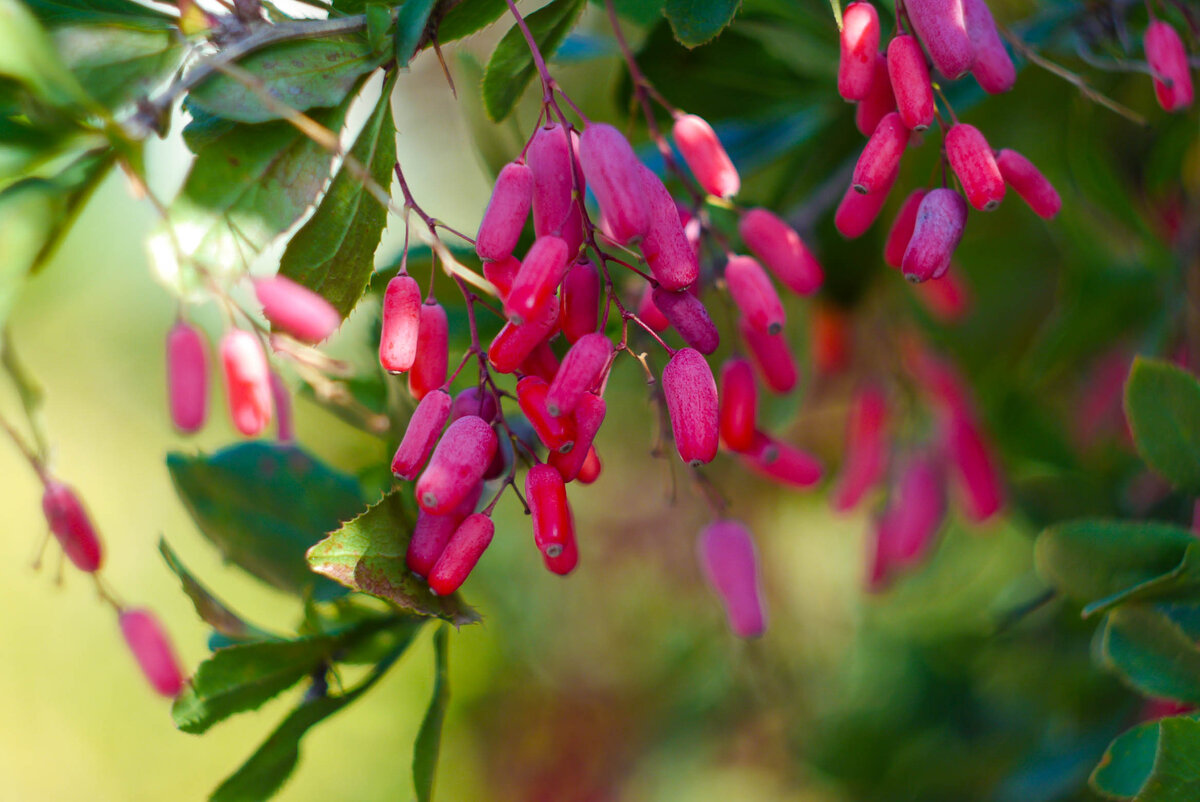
[{"xmin": 696, "ymin": 521, "xmax": 763, "ymax": 638}]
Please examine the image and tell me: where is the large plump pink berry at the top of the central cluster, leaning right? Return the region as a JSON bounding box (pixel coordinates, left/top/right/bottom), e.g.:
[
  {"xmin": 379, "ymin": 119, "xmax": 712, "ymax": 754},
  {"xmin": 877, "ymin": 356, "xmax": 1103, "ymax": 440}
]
[{"xmin": 580, "ymin": 122, "xmax": 650, "ymax": 245}]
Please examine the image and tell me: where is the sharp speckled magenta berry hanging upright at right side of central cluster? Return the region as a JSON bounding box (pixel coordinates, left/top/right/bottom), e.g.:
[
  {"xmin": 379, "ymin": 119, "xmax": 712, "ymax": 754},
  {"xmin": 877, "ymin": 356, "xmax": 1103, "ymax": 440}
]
[{"xmin": 662, "ymin": 348, "xmax": 720, "ymax": 466}]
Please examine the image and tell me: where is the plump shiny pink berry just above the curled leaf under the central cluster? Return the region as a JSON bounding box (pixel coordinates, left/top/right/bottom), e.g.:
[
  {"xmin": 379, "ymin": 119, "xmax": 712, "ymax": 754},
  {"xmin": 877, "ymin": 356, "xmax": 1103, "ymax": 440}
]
[{"xmin": 416, "ymin": 415, "xmax": 496, "ymax": 515}]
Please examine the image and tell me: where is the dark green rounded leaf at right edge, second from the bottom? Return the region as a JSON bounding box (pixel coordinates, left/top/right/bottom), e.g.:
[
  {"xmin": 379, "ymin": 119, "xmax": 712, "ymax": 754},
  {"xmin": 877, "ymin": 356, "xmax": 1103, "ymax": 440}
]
[{"xmin": 1100, "ymin": 604, "xmax": 1200, "ymax": 704}]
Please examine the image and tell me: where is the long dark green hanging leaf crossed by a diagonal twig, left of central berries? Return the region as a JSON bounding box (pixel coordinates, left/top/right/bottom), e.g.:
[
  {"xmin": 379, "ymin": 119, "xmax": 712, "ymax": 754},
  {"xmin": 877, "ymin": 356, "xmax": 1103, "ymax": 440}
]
[{"xmin": 280, "ymin": 71, "xmax": 396, "ymax": 318}]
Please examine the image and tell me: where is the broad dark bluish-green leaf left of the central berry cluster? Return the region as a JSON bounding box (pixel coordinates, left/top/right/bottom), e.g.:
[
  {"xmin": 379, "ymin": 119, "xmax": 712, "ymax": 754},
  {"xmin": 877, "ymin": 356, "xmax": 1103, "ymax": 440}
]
[{"xmin": 167, "ymin": 442, "xmax": 362, "ymax": 600}]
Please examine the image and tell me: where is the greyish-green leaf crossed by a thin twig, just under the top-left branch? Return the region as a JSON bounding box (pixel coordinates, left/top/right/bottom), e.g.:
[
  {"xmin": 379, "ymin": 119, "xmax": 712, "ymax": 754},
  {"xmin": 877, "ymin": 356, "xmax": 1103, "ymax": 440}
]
[{"xmin": 190, "ymin": 35, "xmax": 388, "ymax": 122}]
